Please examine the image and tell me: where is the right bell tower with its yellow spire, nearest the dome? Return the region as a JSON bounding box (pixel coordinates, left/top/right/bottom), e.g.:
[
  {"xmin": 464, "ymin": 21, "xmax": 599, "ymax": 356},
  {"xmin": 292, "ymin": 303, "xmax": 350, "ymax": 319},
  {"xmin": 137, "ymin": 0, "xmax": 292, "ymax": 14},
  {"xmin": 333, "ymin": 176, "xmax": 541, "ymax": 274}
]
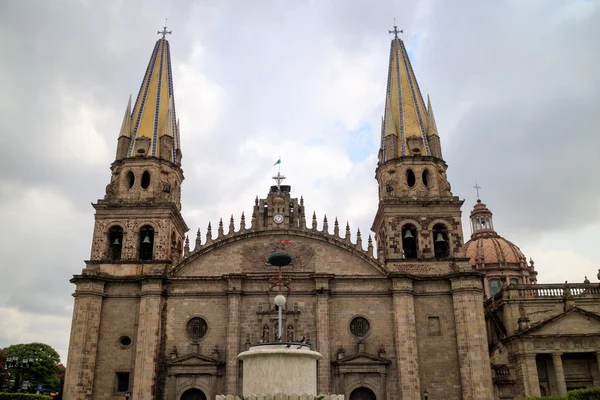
[{"xmin": 372, "ymin": 27, "xmax": 464, "ymax": 264}]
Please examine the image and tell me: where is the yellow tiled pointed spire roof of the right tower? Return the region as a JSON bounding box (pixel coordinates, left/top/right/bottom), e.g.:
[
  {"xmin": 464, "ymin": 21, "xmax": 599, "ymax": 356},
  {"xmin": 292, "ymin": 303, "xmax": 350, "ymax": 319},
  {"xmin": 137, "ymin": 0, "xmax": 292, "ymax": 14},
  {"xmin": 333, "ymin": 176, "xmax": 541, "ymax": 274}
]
[{"xmin": 381, "ymin": 26, "xmax": 437, "ymax": 161}]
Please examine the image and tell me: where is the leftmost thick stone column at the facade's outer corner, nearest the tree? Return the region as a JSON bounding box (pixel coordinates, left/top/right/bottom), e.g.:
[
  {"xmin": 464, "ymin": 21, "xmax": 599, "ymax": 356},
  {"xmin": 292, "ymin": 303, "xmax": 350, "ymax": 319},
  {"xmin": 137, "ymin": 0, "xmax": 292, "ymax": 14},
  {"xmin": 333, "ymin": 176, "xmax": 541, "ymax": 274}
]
[{"xmin": 64, "ymin": 279, "xmax": 104, "ymax": 400}]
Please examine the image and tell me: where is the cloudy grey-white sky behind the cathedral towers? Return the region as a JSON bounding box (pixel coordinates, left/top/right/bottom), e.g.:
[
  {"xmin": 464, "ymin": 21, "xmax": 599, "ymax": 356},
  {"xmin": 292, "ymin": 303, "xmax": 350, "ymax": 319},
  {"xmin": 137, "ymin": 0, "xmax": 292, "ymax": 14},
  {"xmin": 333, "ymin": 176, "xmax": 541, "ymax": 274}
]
[{"xmin": 0, "ymin": 0, "xmax": 600, "ymax": 361}]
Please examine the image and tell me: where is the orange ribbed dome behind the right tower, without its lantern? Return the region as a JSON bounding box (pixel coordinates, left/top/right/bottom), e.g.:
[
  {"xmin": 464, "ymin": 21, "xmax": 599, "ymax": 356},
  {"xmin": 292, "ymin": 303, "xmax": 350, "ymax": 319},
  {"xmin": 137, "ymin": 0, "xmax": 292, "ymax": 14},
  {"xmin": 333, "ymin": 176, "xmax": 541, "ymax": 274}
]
[{"xmin": 465, "ymin": 234, "xmax": 526, "ymax": 265}]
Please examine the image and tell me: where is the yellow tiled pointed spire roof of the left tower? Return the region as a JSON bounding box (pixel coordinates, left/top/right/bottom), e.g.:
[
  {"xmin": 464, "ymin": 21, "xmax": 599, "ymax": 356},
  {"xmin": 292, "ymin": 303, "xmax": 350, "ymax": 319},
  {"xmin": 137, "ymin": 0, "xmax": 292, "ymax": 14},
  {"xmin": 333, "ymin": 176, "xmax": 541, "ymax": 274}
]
[{"xmin": 121, "ymin": 27, "xmax": 180, "ymax": 162}]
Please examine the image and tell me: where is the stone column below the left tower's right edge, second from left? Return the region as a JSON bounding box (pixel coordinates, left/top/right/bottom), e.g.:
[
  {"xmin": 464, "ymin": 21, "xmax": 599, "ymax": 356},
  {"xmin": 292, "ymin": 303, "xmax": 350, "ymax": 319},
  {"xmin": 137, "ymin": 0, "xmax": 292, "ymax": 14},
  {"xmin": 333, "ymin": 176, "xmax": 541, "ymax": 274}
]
[{"xmin": 131, "ymin": 279, "xmax": 162, "ymax": 400}]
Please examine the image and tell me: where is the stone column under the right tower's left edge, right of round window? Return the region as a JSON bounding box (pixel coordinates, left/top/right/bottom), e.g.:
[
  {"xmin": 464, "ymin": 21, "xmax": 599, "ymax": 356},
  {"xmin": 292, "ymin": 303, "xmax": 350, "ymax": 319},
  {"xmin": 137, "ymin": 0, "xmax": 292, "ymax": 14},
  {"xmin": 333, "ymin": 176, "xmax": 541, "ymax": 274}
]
[{"xmin": 392, "ymin": 278, "xmax": 420, "ymax": 400}]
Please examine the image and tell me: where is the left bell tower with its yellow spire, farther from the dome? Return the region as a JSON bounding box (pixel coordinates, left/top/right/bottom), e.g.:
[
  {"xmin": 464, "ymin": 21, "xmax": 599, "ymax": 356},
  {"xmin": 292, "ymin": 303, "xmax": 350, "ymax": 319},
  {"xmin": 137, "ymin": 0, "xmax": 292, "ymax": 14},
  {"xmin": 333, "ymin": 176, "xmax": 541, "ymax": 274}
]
[{"xmin": 89, "ymin": 28, "xmax": 188, "ymax": 266}]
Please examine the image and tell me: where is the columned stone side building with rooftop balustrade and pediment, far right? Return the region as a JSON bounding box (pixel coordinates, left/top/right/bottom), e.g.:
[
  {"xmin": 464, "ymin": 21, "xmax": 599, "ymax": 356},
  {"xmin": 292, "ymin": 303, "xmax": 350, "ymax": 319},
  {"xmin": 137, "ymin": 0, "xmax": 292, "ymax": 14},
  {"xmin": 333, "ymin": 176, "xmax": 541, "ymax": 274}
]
[{"xmin": 485, "ymin": 282, "xmax": 600, "ymax": 399}]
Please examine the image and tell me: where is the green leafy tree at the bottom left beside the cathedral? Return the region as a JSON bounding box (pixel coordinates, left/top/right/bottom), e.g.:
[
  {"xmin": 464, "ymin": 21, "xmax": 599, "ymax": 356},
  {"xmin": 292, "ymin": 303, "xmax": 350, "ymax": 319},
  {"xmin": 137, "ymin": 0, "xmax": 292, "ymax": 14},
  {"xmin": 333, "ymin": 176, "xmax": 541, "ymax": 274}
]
[{"xmin": 4, "ymin": 343, "xmax": 60, "ymax": 390}]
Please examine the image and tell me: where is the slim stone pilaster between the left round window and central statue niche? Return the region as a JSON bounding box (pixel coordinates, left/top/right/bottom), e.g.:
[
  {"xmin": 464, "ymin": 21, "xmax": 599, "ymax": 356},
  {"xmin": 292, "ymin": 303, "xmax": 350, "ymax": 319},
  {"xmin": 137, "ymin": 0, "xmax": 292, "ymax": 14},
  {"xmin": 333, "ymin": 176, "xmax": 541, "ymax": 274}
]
[{"xmin": 225, "ymin": 275, "xmax": 242, "ymax": 395}]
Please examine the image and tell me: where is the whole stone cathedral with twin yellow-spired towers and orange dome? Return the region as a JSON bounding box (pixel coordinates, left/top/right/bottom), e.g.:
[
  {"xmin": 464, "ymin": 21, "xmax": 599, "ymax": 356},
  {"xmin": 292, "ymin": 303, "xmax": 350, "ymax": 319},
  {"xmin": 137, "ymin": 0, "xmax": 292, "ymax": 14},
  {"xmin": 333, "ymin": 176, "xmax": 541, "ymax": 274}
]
[{"xmin": 65, "ymin": 28, "xmax": 600, "ymax": 400}]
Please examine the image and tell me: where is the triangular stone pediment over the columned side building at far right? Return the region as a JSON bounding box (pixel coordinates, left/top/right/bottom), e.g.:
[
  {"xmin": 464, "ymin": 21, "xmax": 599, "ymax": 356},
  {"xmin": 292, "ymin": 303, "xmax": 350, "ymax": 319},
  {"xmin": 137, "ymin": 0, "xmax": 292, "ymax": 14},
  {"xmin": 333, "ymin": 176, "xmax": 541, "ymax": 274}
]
[{"xmin": 519, "ymin": 307, "xmax": 600, "ymax": 336}]
